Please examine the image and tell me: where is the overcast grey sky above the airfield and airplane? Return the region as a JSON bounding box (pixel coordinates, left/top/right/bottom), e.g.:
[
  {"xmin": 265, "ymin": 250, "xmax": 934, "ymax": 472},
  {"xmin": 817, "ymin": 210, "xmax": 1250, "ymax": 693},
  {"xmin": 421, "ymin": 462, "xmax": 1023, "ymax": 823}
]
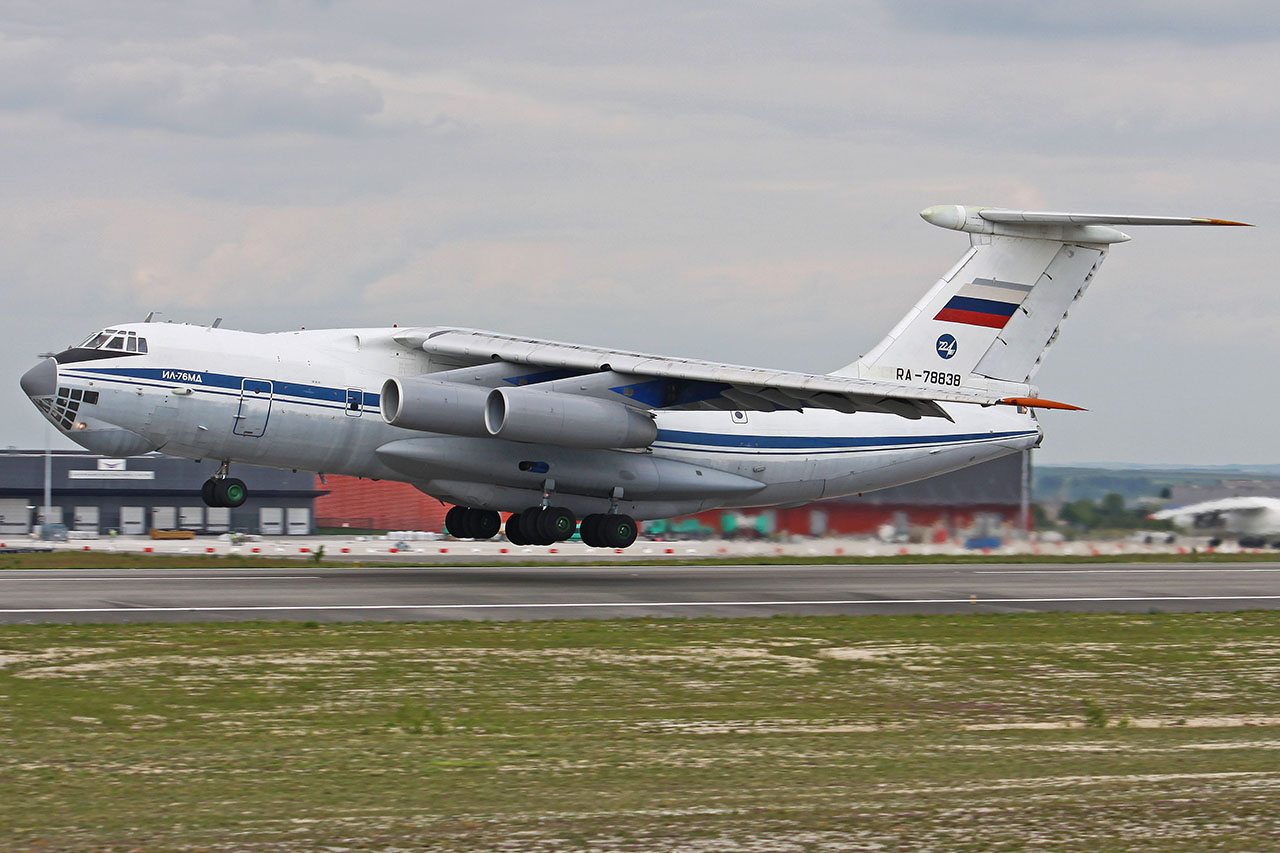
[{"xmin": 0, "ymin": 0, "xmax": 1280, "ymax": 465}]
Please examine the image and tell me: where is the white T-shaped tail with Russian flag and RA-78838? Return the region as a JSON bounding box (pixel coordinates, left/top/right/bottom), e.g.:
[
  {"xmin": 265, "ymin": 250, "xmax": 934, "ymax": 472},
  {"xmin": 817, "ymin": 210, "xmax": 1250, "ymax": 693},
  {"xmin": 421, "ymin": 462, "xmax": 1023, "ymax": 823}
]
[{"xmin": 836, "ymin": 205, "xmax": 1245, "ymax": 388}]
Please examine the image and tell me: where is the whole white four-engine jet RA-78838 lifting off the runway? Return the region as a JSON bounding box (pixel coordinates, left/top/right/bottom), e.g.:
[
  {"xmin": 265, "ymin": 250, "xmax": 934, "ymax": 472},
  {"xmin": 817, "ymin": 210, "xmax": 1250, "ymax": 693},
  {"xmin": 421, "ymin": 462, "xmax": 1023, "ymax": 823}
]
[{"xmin": 22, "ymin": 205, "xmax": 1244, "ymax": 548}]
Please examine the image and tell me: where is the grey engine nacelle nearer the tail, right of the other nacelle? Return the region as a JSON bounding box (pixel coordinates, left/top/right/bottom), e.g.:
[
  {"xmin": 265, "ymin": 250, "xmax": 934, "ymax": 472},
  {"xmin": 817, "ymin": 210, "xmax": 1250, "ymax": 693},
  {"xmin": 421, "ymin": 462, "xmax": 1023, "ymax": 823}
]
[{"xmin": 484, "ymin": 388, "xmax": 658, "ymax": 450}]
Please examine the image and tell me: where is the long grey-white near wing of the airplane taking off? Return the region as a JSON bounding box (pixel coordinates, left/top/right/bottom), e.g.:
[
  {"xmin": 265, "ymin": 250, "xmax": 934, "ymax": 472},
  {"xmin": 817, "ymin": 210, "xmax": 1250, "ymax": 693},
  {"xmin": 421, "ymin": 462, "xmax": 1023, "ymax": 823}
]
[{"xmin": 396, "ymin": 328, "xmax": 1032, "ymax": 420}]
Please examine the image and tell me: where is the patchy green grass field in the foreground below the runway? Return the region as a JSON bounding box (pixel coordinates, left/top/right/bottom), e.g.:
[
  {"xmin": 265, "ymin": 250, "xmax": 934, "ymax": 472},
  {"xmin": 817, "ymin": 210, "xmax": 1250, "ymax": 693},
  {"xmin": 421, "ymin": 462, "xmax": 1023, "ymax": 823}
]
[{"xmin": 0, "ymin": 612, "xmax": 1280, "ymax": 853}]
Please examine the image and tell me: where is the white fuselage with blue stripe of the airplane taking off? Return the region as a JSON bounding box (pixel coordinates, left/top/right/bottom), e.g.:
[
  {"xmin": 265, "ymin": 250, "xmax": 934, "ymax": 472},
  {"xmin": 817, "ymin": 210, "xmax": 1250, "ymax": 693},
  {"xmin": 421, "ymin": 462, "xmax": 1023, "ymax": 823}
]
[{"xmin": 24, "ymin": 323, "xmax": 1039, "ymax": 519}]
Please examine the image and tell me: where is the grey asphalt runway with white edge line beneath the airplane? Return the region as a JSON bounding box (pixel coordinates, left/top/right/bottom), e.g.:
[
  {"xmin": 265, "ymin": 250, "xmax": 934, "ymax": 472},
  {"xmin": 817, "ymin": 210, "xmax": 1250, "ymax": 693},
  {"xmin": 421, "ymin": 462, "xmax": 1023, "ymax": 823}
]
[{"xmin": 0, "ymin": 562, "xmax": 1280, "ymax": 624}]
